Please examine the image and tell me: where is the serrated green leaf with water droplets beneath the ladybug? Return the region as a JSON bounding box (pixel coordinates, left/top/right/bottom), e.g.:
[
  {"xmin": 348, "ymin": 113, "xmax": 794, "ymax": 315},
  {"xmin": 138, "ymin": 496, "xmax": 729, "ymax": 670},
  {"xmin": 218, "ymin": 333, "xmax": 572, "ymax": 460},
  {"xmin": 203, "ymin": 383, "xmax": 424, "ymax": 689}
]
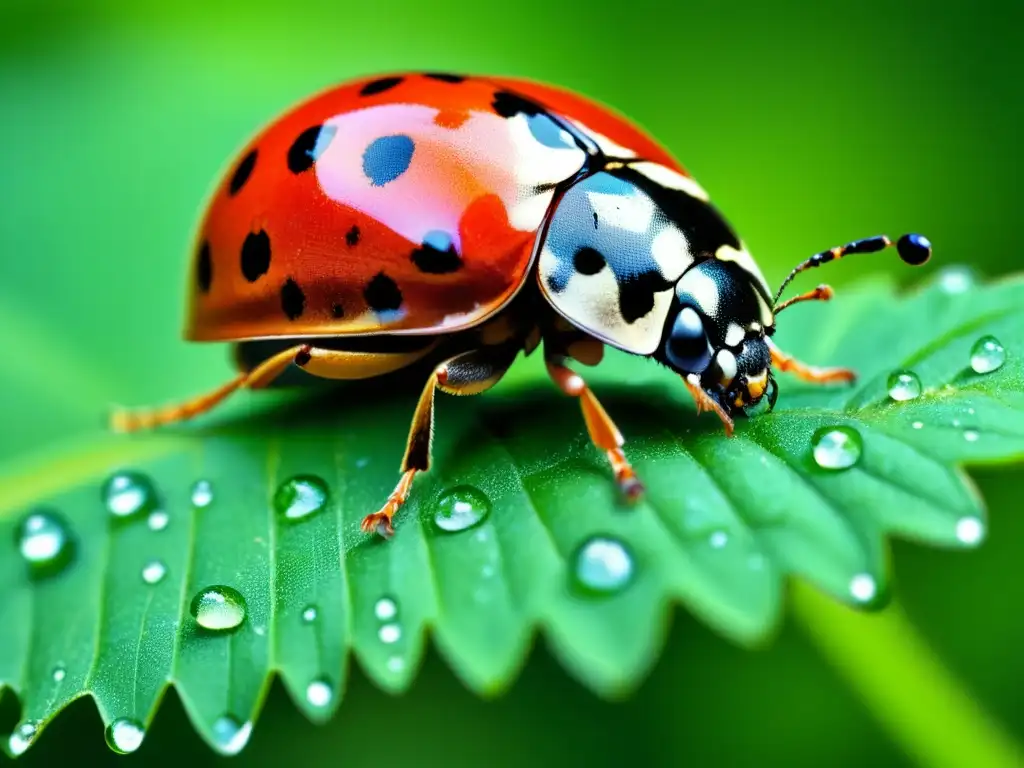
[{"xmin": 0, "ymin": 270, "xmax": 1024, "ymax": 753}]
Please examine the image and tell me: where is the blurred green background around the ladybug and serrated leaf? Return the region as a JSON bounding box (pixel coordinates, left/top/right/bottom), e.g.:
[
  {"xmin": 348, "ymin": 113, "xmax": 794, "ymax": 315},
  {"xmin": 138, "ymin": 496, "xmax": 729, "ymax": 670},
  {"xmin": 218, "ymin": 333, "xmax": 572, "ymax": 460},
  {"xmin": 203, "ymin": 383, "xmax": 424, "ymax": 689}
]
[{"xmin": 0, "ymin": 0, "xmax": 1024, "ymax": 767}]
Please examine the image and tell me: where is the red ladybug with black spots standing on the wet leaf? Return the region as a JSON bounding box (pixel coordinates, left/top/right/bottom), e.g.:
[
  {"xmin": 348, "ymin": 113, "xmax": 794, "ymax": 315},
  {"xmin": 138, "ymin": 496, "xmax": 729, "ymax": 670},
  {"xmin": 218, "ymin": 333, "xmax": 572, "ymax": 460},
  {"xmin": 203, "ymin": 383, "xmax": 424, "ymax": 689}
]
[{"xmin": 114, "ymin": 73, "xmax": 931, "ymax": 537}]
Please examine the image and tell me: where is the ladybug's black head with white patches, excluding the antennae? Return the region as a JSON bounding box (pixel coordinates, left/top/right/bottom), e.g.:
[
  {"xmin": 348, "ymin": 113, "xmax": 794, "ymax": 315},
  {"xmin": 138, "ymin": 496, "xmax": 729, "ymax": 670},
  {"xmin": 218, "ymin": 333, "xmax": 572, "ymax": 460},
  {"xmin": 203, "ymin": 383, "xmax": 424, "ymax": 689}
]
[{"xmin": 654, "ymin": 259, "xmax": 776, "ymax": 414}]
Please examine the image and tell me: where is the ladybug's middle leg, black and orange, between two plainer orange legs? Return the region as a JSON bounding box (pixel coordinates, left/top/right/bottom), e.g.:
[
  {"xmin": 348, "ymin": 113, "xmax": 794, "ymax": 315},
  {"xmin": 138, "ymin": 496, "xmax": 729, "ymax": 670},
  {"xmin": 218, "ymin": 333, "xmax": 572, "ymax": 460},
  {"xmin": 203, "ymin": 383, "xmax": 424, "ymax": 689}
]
[{"xmin": 361, "ymin": 342, "xmax": 522, "ymax": 538}]
